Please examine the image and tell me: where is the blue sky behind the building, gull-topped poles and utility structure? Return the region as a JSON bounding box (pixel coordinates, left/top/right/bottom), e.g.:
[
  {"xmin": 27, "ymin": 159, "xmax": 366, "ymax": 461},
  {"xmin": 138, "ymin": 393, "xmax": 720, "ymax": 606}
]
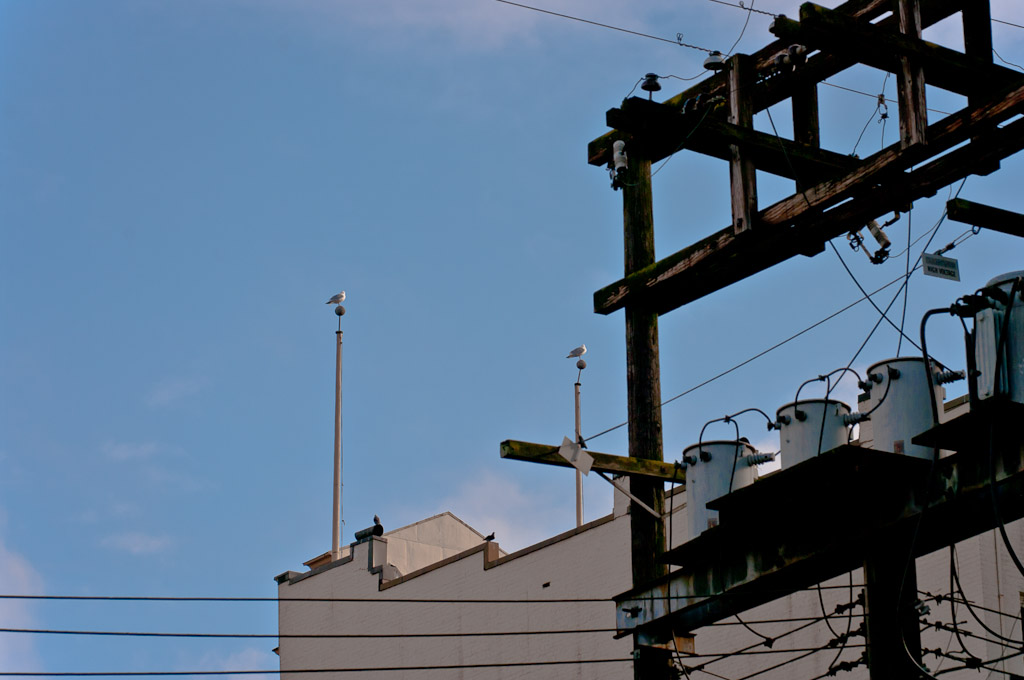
[{"xmin": 0, "ymin": 0, "xmax": 1024, "ymax": 671}]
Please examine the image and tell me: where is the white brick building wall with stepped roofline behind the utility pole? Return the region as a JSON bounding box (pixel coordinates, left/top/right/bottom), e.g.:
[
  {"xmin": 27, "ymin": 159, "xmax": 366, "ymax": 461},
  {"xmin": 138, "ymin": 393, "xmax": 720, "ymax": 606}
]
[{"xmin": 279, "ymin": 483, "xmax": 1024, "ymax": 680}]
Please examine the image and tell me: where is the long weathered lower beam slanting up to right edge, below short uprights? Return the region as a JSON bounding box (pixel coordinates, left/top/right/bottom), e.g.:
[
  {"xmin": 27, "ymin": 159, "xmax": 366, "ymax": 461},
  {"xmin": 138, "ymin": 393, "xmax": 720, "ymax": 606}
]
[{"xmin": 594, "ymin": 81, "xmax": 1024, "ymax": 314}]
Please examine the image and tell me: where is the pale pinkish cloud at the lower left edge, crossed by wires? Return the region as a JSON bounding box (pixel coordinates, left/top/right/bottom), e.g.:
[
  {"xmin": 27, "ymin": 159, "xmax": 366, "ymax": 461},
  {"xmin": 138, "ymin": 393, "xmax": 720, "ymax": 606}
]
[{"xmin": 0, "ymin": 540, "xmax": 43, "ymax": 673}]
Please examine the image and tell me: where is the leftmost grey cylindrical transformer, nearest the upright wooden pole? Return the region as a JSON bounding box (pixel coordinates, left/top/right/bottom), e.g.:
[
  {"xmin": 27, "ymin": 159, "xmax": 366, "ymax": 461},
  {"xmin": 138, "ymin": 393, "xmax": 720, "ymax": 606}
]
[{"xmin": 683, "ymin": 441, "xmax": 757, "ymax": 541}]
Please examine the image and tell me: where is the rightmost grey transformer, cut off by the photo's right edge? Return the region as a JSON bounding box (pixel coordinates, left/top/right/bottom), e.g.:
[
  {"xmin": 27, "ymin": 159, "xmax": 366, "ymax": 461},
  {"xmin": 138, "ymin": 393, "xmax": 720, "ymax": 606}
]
[{"xmin": 974, "ymin": 271, "xmax": 1024, "ymax": 403}]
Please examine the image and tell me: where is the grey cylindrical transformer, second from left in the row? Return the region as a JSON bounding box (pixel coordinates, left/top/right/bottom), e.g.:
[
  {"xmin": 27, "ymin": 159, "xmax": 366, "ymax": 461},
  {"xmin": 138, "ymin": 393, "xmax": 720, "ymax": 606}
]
[{"xmin": 775, "ymin": 399, "xmax": 850, "ymax": 470}]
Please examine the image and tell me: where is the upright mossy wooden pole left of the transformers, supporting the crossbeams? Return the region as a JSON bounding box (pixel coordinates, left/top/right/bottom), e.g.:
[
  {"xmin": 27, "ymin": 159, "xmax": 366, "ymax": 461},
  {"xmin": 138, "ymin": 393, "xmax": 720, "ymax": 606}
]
[{"xmin": 623, "ymin": 153, "xmax": 672, "ymax": 680}]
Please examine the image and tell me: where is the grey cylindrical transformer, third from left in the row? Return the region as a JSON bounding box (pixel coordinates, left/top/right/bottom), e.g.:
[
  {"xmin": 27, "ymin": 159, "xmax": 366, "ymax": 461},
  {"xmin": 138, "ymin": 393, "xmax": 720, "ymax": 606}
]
[{"xmin": 860, "ymin": 356, "xmax": 944, "ymax": 460}]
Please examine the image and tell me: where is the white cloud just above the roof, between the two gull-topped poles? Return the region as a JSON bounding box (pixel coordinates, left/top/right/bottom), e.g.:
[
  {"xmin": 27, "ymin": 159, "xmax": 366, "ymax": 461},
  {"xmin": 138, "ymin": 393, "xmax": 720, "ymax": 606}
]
[{"xmin": 434, "ymin": 471, "xmax": 572, "ymax": 552}]
